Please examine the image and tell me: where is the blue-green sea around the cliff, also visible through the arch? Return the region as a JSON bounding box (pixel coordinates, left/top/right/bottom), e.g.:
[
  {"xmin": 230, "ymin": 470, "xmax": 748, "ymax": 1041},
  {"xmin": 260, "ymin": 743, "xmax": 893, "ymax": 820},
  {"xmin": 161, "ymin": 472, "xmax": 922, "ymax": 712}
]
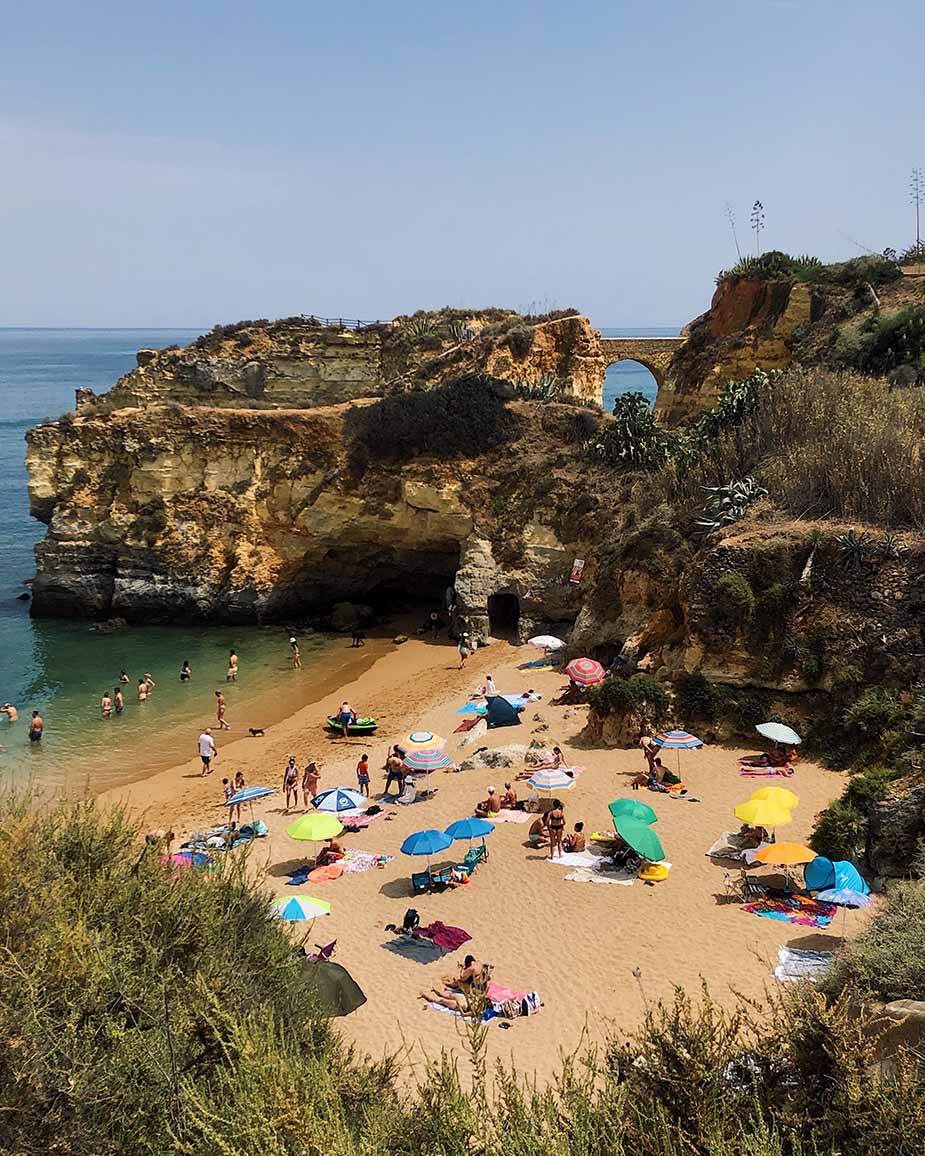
[{"xmin": 0, "ymin": 327, "xmax": 679, "ymax": 795}]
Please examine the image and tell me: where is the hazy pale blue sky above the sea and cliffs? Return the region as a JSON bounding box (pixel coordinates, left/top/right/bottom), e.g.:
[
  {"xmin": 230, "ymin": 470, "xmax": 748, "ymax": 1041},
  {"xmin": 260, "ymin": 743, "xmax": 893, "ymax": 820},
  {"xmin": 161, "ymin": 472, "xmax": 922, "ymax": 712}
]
[{"xmin": 0, "ymin": 0, "xmax": 925, "ymax": 326}]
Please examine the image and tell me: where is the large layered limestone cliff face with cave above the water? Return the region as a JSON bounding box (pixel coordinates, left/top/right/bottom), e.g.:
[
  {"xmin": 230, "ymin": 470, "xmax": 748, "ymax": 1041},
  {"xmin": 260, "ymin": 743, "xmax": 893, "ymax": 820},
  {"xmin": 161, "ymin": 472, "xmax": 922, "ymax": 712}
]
[{"xmin": 27, "ymin": 402, "xmax": 601, "ymax": 635}]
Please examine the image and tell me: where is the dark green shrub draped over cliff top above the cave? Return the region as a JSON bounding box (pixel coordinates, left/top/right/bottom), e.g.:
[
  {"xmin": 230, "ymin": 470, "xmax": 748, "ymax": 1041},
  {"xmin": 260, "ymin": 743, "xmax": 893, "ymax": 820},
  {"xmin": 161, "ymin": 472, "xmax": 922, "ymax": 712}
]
[{"xmin": 347, "ymin": 373, "xmax": 518, "ymax": 461}]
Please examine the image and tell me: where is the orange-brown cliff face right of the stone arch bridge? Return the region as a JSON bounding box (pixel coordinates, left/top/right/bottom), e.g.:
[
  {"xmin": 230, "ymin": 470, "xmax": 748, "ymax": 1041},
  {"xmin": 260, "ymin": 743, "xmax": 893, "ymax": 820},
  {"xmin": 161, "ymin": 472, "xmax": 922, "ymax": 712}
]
[{"xmin": 656, "ymin": 277, "xmax": 821, "ymax": 422}]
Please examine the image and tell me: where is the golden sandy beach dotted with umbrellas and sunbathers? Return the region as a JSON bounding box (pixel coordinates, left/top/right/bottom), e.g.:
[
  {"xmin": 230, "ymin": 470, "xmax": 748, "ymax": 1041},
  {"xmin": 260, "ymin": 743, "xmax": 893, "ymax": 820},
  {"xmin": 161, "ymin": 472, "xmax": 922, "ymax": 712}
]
[{"xmin": 103, "ymin": 638, "xmax": 865, "ymax": 1080}]
